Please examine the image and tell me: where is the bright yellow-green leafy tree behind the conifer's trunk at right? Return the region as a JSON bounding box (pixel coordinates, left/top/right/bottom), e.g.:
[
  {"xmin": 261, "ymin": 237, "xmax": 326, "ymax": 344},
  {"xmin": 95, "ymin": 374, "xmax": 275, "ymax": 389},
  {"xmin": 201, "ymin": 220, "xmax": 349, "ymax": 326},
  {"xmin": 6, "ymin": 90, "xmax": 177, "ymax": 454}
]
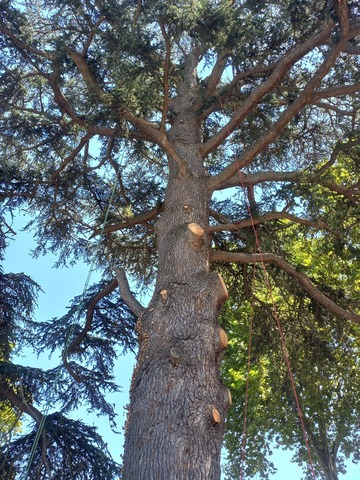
[{"xmin": 222, "ymin": 152, "xmax": 360, "ymax": 480}]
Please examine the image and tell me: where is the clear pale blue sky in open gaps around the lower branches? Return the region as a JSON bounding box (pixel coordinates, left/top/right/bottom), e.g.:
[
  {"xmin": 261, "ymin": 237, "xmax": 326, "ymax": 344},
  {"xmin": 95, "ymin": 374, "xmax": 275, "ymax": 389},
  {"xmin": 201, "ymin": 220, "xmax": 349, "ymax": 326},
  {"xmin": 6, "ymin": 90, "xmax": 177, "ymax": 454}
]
[{"xmin": 3, "ymin": 217, "xmax": 360, "ymax": 480}]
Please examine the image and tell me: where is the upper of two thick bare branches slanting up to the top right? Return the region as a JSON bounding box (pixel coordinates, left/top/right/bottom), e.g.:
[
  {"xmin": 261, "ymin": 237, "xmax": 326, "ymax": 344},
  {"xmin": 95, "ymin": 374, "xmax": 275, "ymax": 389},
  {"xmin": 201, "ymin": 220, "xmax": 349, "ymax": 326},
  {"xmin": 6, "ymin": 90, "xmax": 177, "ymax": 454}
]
[{"xmin": 201, "ymin": 23, "xmax": 334, "ymax": 157}]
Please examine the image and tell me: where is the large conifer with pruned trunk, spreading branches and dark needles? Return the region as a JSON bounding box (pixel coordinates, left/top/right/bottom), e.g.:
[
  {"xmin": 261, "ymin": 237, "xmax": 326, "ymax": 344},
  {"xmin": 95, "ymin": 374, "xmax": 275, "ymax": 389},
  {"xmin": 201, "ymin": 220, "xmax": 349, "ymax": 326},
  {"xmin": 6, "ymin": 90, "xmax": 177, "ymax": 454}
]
[{"xmin": 0, "ymin": 0, "xmax": 360, "ymax": 480}]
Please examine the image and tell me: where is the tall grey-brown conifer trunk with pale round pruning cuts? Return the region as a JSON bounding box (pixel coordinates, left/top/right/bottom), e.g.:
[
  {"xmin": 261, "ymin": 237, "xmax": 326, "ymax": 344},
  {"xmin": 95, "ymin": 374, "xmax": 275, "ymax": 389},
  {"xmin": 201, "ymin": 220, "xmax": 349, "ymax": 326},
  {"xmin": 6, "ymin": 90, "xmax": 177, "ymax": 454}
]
[{"xmin": 123, "ymin": 52, "xmax": 229, "ymax": 480}]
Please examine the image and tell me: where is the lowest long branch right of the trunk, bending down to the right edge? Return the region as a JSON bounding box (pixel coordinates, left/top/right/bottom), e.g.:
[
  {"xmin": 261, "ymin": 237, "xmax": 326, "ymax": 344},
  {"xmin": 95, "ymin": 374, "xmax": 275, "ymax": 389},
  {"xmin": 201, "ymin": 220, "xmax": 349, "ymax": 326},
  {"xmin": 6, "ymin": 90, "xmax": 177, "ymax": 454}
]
[{"xmin": 211, "ymin": 251, "xmax": 360, "ymax": 324}]
